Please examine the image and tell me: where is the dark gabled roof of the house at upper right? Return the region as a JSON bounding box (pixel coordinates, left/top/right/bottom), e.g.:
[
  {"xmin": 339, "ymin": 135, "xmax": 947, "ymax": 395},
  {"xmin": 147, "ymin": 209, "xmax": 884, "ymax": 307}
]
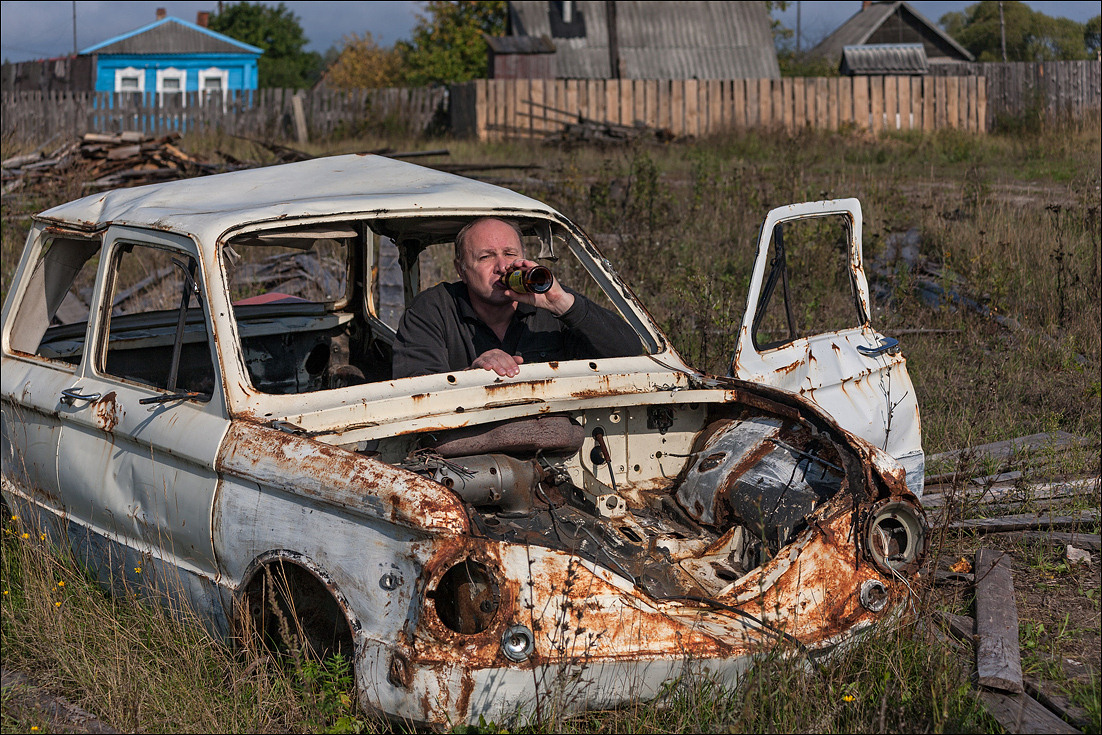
[{"xmin": 808, "ymin": 1, "xmax": 975, "ymax": 62}]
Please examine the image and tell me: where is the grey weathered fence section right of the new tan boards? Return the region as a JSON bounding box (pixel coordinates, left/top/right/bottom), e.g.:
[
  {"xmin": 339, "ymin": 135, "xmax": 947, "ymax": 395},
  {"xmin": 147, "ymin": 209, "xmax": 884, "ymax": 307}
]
[{"xmin": 930, "ymin": 61, "xmax": 1102, "ymax": 130}]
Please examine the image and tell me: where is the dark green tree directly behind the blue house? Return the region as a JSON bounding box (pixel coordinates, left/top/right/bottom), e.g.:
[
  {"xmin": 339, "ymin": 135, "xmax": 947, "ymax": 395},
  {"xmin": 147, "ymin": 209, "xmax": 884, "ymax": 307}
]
[{"xmin": 208, "ymin": 2, "xmax": 322, "ymax": 88}]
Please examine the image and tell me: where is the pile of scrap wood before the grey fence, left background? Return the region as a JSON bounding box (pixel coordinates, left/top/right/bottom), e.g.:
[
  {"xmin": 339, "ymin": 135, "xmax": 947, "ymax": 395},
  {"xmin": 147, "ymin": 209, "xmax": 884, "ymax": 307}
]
[{"xmin": 2, "ymin": 132, "xmax": 226, "ymax": 194}]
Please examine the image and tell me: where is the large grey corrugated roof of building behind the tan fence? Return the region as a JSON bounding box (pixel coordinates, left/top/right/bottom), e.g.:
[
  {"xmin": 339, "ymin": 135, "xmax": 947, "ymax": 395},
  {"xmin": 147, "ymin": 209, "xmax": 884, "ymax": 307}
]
[{"xmin": 509, "ymin": 0, "xmax": 780, "ymax": 79}]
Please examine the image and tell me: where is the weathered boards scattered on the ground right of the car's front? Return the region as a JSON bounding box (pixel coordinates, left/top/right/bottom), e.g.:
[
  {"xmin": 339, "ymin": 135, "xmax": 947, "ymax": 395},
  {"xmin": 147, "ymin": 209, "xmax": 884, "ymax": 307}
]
[{"xmin": 922, "ymin": 432, "xmax": 1102, "ymax": 733}]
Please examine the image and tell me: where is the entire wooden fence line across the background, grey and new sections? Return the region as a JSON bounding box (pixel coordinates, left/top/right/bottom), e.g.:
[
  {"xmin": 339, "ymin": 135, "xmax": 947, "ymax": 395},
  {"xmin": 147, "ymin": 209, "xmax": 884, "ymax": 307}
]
[{"xmin": 0, "ymin": 62, "xmax": 1102, "ymax": 140}]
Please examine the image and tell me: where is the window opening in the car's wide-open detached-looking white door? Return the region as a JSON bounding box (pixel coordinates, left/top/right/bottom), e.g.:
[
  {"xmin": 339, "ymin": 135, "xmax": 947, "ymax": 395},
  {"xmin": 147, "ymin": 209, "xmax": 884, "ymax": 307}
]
[{"xmin": 753, "ymin": 215, "xmax": 867, "ymax": 349}]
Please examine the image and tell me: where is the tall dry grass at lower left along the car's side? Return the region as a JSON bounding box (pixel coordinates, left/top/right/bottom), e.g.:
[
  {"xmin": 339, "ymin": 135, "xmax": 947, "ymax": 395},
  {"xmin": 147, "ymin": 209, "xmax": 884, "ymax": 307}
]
[{"xmin": 0, "ymin": 508, "xmax": 379, "ymax": 733}]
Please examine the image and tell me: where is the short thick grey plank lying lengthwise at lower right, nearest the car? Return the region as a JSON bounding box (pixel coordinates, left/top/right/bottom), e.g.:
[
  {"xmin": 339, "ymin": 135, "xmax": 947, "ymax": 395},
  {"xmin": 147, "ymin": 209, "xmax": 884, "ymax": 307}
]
[{"xmin": 974, "ymin": 549, "xmax": 1025, "ymax": 693}]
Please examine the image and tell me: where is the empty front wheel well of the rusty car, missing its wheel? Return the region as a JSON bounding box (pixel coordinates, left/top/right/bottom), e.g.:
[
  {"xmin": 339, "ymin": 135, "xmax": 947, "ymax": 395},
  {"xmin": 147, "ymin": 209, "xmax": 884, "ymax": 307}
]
[{"xmin": 238, "ymin": 556, "xmax": 355, "ymax": 660}]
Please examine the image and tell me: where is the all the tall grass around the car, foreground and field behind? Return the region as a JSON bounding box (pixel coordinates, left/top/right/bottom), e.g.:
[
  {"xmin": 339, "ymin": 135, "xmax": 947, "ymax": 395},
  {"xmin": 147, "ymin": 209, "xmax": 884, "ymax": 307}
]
[{"xmin": 0, "ymin": 125, "xmax": 1102, "ymax": 732}]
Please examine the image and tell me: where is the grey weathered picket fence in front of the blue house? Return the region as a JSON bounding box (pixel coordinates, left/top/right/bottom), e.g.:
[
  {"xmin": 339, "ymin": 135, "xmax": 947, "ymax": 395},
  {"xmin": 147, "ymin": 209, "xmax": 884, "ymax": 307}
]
[{"xmin": 0, "ymin": 87, "xmax": 447, "ymax": 140}]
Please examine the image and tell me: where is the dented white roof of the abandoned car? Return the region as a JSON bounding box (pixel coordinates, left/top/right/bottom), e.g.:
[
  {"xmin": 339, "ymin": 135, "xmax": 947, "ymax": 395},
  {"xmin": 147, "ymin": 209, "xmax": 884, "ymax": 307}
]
[{"xmin": 36, "ymin": 154, "xmax": 557, "ymax": 244}]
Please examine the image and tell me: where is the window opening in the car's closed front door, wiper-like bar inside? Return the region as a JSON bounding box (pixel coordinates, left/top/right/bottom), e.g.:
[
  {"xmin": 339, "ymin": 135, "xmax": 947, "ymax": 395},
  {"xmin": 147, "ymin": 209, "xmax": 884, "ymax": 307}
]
[{"xmin": 97, "ymin": 244, "xmax": 215, "ymax": 401}]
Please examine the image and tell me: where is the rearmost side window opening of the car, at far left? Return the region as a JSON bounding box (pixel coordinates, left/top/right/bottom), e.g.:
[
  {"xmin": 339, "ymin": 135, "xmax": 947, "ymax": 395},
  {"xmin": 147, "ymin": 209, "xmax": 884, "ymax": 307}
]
[{"xmin": 10, "ymin": 238, "xmax": 101, "ymax": 365}]
